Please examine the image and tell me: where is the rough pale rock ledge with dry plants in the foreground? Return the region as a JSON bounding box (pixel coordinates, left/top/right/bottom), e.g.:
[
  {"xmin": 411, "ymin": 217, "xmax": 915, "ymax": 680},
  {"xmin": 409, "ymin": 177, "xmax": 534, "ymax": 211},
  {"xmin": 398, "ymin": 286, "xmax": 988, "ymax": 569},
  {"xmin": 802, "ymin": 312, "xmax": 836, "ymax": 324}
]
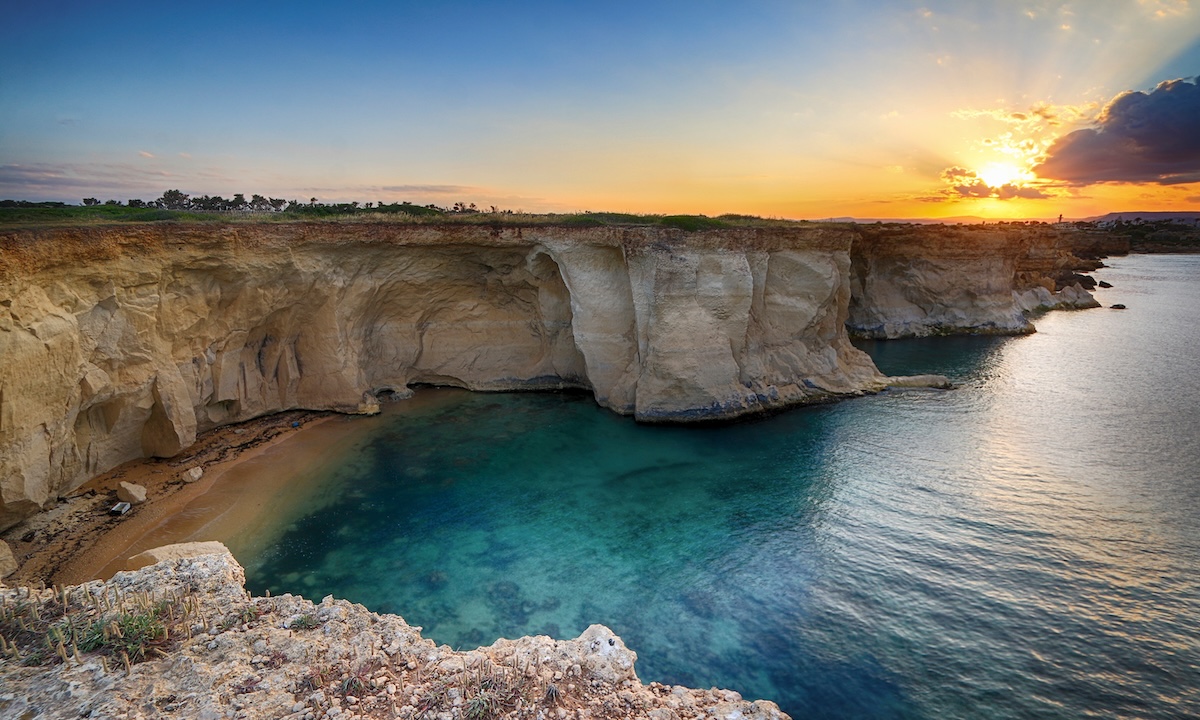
[{"xmin": 0, "ymin": 544, "xmax": 787, "ymax": 720}]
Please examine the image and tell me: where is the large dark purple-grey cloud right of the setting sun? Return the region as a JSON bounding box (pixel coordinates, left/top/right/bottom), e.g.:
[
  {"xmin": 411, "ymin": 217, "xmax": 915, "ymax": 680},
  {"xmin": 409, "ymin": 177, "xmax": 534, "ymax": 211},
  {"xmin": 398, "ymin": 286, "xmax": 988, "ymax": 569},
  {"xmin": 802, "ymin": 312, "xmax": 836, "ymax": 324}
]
[{"xmin": 1033, "ymin": 79, "xmax": 1200, "ymax": 185}]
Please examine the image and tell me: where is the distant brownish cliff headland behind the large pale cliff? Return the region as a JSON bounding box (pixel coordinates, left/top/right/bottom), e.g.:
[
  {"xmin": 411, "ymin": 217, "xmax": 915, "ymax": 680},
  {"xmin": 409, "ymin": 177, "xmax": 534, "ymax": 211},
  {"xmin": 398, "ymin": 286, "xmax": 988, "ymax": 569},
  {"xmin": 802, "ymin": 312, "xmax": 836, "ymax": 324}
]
[{"xmin": 847, "ymin": 223, "xmax": 1109, "ymax": 338}]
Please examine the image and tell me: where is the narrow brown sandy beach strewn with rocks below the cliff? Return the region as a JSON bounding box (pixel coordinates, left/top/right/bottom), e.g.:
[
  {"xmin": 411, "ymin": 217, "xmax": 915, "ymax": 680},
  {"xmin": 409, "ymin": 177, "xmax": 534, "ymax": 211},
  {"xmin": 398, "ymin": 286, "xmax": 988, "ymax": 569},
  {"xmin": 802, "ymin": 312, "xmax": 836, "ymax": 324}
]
[{"xmin": 0, "ymin": 410, "xmax": 364, "ymax": 587}]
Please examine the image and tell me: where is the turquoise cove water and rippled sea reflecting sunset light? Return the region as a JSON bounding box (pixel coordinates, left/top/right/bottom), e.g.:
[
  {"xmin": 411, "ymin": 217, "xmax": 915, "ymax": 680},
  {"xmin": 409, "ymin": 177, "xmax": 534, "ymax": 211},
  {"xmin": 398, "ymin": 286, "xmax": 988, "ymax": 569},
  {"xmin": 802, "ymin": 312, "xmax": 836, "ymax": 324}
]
[{"xmin": 247, "ymin": 256, "xmax": 1200, "ymax": 719}]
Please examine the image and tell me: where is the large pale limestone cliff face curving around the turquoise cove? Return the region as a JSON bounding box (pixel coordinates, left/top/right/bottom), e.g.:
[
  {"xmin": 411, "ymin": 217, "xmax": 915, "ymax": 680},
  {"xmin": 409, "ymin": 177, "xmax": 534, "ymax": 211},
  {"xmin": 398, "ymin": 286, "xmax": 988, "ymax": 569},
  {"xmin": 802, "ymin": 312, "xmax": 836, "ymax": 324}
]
[{"xmin": 0, "ymin": 224, "xmax": 884, "ymax": 528}]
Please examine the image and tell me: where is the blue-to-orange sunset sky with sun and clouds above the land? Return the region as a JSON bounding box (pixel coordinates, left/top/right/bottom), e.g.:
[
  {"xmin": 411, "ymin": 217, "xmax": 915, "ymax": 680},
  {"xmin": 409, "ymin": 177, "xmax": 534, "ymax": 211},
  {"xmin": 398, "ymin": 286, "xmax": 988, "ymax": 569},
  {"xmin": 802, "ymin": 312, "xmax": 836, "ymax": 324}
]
[{"xmin": 0, "ymin": 0, "xmax": 1200, "ymax": 218}]
